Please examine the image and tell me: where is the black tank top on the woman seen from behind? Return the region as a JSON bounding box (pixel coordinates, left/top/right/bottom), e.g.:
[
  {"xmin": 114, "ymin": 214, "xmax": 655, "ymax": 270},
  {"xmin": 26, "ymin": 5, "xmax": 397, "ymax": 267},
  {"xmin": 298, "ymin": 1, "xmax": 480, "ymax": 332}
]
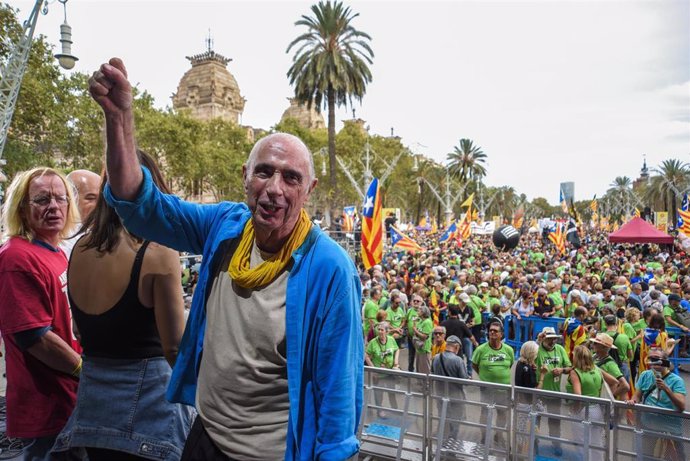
[{"xmin": 67, "ymin": 241, "xmax": 163, "ymax": 359}]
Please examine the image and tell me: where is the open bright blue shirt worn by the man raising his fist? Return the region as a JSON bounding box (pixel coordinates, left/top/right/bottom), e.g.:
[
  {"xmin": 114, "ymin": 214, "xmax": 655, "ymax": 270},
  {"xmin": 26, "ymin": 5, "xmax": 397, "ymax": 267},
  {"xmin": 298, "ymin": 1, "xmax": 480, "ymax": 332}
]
[{"xmin": 103, "ymin": 167, "xmax": 364, "ymax": 460}]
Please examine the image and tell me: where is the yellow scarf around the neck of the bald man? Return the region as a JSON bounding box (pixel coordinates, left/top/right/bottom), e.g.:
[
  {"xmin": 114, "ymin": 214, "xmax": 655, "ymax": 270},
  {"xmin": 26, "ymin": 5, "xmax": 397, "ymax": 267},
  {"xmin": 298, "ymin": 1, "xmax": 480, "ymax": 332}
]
[{"xmin": 228, "ymin": 210, "xmax": 311, "ymax": 288}]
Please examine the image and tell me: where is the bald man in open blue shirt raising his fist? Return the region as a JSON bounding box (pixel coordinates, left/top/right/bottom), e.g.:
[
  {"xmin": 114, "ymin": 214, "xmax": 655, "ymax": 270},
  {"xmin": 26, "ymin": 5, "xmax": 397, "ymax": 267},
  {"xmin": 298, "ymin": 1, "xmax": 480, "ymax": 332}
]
[{"xmin": 89, "ymin": 59, "xmax": 364, "ymax": 461}]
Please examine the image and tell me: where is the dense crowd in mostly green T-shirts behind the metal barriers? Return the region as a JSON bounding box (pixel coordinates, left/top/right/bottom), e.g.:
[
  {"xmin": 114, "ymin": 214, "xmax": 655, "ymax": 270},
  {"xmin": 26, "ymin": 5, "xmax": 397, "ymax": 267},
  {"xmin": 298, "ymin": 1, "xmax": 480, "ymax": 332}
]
[{"xmin": 360, "ymin": 226, "xmax": 690, "ymax": 454}]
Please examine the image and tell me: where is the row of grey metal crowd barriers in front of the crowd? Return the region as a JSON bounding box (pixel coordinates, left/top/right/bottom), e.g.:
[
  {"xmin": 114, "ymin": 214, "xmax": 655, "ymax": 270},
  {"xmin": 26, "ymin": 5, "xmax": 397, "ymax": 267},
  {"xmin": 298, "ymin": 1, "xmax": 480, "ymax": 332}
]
[{"xmin": 359, "ymin": 367, "xmax": 690, "ymax": 461}]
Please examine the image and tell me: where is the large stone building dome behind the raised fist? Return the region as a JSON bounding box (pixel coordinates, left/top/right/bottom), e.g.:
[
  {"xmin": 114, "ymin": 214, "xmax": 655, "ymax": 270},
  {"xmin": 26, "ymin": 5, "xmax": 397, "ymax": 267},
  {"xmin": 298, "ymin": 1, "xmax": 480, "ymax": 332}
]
[{"xmin": 172, "ymin": 47, "xmax": 246, "ymax": 125}]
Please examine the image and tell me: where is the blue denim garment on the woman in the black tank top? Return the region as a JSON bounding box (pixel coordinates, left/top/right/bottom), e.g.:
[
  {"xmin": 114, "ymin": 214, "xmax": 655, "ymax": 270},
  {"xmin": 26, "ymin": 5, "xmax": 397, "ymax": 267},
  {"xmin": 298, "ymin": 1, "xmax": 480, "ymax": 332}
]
[{"xmin": 54, "ymin": 356, "xmax": 196, "ymax": 461}]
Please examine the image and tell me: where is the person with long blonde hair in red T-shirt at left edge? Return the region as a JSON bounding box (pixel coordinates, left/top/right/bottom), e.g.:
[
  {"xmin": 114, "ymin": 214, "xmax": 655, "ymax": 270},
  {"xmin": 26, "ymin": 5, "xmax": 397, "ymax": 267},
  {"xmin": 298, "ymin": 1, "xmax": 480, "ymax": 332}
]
[{"xmin": 0, "ymin": 168, "xmax": 81, "ymax": 459}]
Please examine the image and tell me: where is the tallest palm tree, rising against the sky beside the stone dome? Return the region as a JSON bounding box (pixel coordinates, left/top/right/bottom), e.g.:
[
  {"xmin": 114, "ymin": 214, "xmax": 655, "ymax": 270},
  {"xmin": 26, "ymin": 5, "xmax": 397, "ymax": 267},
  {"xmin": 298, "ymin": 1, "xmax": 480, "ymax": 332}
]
[{"xmin": 286, "ymin": 0, "xmax": 374, "ymax": 207}]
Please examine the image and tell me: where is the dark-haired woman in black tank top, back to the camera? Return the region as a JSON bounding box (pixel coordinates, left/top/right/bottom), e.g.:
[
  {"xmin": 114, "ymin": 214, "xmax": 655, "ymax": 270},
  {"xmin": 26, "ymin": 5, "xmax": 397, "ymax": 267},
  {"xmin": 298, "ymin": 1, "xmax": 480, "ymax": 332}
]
[{"xmin": 53, "ymin": 151, "xmax": 193, "ymax": 461}]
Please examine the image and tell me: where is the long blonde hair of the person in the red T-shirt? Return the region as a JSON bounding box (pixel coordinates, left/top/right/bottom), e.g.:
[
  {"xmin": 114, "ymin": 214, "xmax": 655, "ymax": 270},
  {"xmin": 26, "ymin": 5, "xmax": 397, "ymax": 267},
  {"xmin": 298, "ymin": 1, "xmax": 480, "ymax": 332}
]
[{"xmin": 2, "ymin": 167, "xmax": 79, "ymax": 240}]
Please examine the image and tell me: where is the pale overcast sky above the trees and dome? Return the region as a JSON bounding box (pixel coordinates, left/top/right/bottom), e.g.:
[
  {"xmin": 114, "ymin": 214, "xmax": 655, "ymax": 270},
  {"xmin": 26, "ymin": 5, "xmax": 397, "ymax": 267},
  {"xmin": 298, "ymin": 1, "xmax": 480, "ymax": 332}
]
[{"xmin": 8, "ymin": 0, "xmax": 690, "ymax": 204}]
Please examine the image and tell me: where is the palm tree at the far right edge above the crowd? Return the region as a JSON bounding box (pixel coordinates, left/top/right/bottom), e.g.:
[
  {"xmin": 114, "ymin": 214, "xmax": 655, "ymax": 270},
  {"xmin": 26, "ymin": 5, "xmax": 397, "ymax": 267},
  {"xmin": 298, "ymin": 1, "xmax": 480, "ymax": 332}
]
[{"xmin": 647, "ymin": 159, "xmax": 690, "ymax": 226}]
